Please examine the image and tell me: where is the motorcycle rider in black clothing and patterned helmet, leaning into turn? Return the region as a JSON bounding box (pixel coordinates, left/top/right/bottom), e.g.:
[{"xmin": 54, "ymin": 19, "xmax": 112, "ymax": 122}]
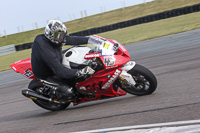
[{"xmin": 31, "ymin": 20, "xmax": 101, "ymax": 101}]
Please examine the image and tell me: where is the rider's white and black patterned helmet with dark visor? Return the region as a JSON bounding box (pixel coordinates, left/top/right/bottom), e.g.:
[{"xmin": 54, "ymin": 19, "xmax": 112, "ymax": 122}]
[{"xmin": 44, "ymin": 20, "xmax": 67, "ymax": 46}]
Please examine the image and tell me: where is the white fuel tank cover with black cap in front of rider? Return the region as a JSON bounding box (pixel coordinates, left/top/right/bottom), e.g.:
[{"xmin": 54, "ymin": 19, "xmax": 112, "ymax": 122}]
[{"xmin": 62, "ymin": 47, "xmax": 91, "ymax": 69}]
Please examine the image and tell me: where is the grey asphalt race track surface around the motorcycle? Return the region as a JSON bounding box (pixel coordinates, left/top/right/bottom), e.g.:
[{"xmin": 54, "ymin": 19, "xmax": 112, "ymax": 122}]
[{"xmin": 0, "ymin": 29, "xmax": 200, "ymax": 133}]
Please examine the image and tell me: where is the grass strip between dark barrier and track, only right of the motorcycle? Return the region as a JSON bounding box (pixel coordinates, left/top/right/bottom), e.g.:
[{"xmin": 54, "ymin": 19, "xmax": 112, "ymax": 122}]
[{"xmin": 99, "ymin": 12, "xmax": 200, "ymax": 44}]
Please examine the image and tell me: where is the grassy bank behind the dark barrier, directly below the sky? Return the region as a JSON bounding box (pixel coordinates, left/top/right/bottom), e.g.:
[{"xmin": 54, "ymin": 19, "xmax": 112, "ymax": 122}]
[{"xmin": 0, "ymin": 0, "xmax": 200, "ymax": 46}]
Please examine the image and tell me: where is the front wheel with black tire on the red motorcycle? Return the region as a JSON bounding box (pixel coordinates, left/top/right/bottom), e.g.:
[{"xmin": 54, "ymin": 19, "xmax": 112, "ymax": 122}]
[{"xmin": 122, "ymin": 64, "xmax": 157, "ymax": 96}]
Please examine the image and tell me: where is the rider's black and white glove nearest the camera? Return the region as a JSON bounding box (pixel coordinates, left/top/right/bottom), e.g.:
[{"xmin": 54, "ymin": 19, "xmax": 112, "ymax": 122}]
[{"xmin": 75, "ymin": 66, "xmax": 95, "ymax": 78}]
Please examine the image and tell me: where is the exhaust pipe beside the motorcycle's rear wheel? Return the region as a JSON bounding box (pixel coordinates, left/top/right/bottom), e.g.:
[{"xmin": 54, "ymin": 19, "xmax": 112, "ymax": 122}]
[{"xmin": 22, "ymin": 89, "xmax": 56, "ymax": 103}]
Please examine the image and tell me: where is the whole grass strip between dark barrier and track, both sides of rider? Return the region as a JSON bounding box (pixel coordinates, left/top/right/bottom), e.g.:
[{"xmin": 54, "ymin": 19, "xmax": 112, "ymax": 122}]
[{"xmin": 0, "ymin": 12, "xmax": 200, "ymax": 71}]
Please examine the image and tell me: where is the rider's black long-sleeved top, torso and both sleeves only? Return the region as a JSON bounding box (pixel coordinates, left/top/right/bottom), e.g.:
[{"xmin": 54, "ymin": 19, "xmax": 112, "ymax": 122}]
[{"xmin": 31, "ymin": 34, "xmax": 88, "ymax": 79}]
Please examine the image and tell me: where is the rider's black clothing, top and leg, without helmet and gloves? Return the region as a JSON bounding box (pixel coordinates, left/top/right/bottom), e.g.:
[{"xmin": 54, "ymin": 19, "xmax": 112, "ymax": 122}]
[{"xmin": 31, "ymin": 34, "xmax": 89, "ymax": 101}]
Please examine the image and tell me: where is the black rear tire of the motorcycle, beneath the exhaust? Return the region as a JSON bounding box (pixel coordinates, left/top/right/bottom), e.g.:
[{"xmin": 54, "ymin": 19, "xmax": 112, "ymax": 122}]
[{"xmin": 32, "ymin": 87, "xmax": 70, "ymax": 111}]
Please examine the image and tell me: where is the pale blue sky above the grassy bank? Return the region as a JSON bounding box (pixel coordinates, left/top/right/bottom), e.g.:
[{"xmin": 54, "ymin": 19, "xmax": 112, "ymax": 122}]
[{"xmin": 0, "ymin": 0, "xmax": 153, "ymax": 36}]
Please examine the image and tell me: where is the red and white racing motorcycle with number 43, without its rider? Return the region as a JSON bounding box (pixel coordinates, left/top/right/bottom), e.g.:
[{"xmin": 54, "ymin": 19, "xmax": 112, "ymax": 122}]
[{"xmin": 10, "ymin": 35, "xmax": 157, "ymax": 111}]
